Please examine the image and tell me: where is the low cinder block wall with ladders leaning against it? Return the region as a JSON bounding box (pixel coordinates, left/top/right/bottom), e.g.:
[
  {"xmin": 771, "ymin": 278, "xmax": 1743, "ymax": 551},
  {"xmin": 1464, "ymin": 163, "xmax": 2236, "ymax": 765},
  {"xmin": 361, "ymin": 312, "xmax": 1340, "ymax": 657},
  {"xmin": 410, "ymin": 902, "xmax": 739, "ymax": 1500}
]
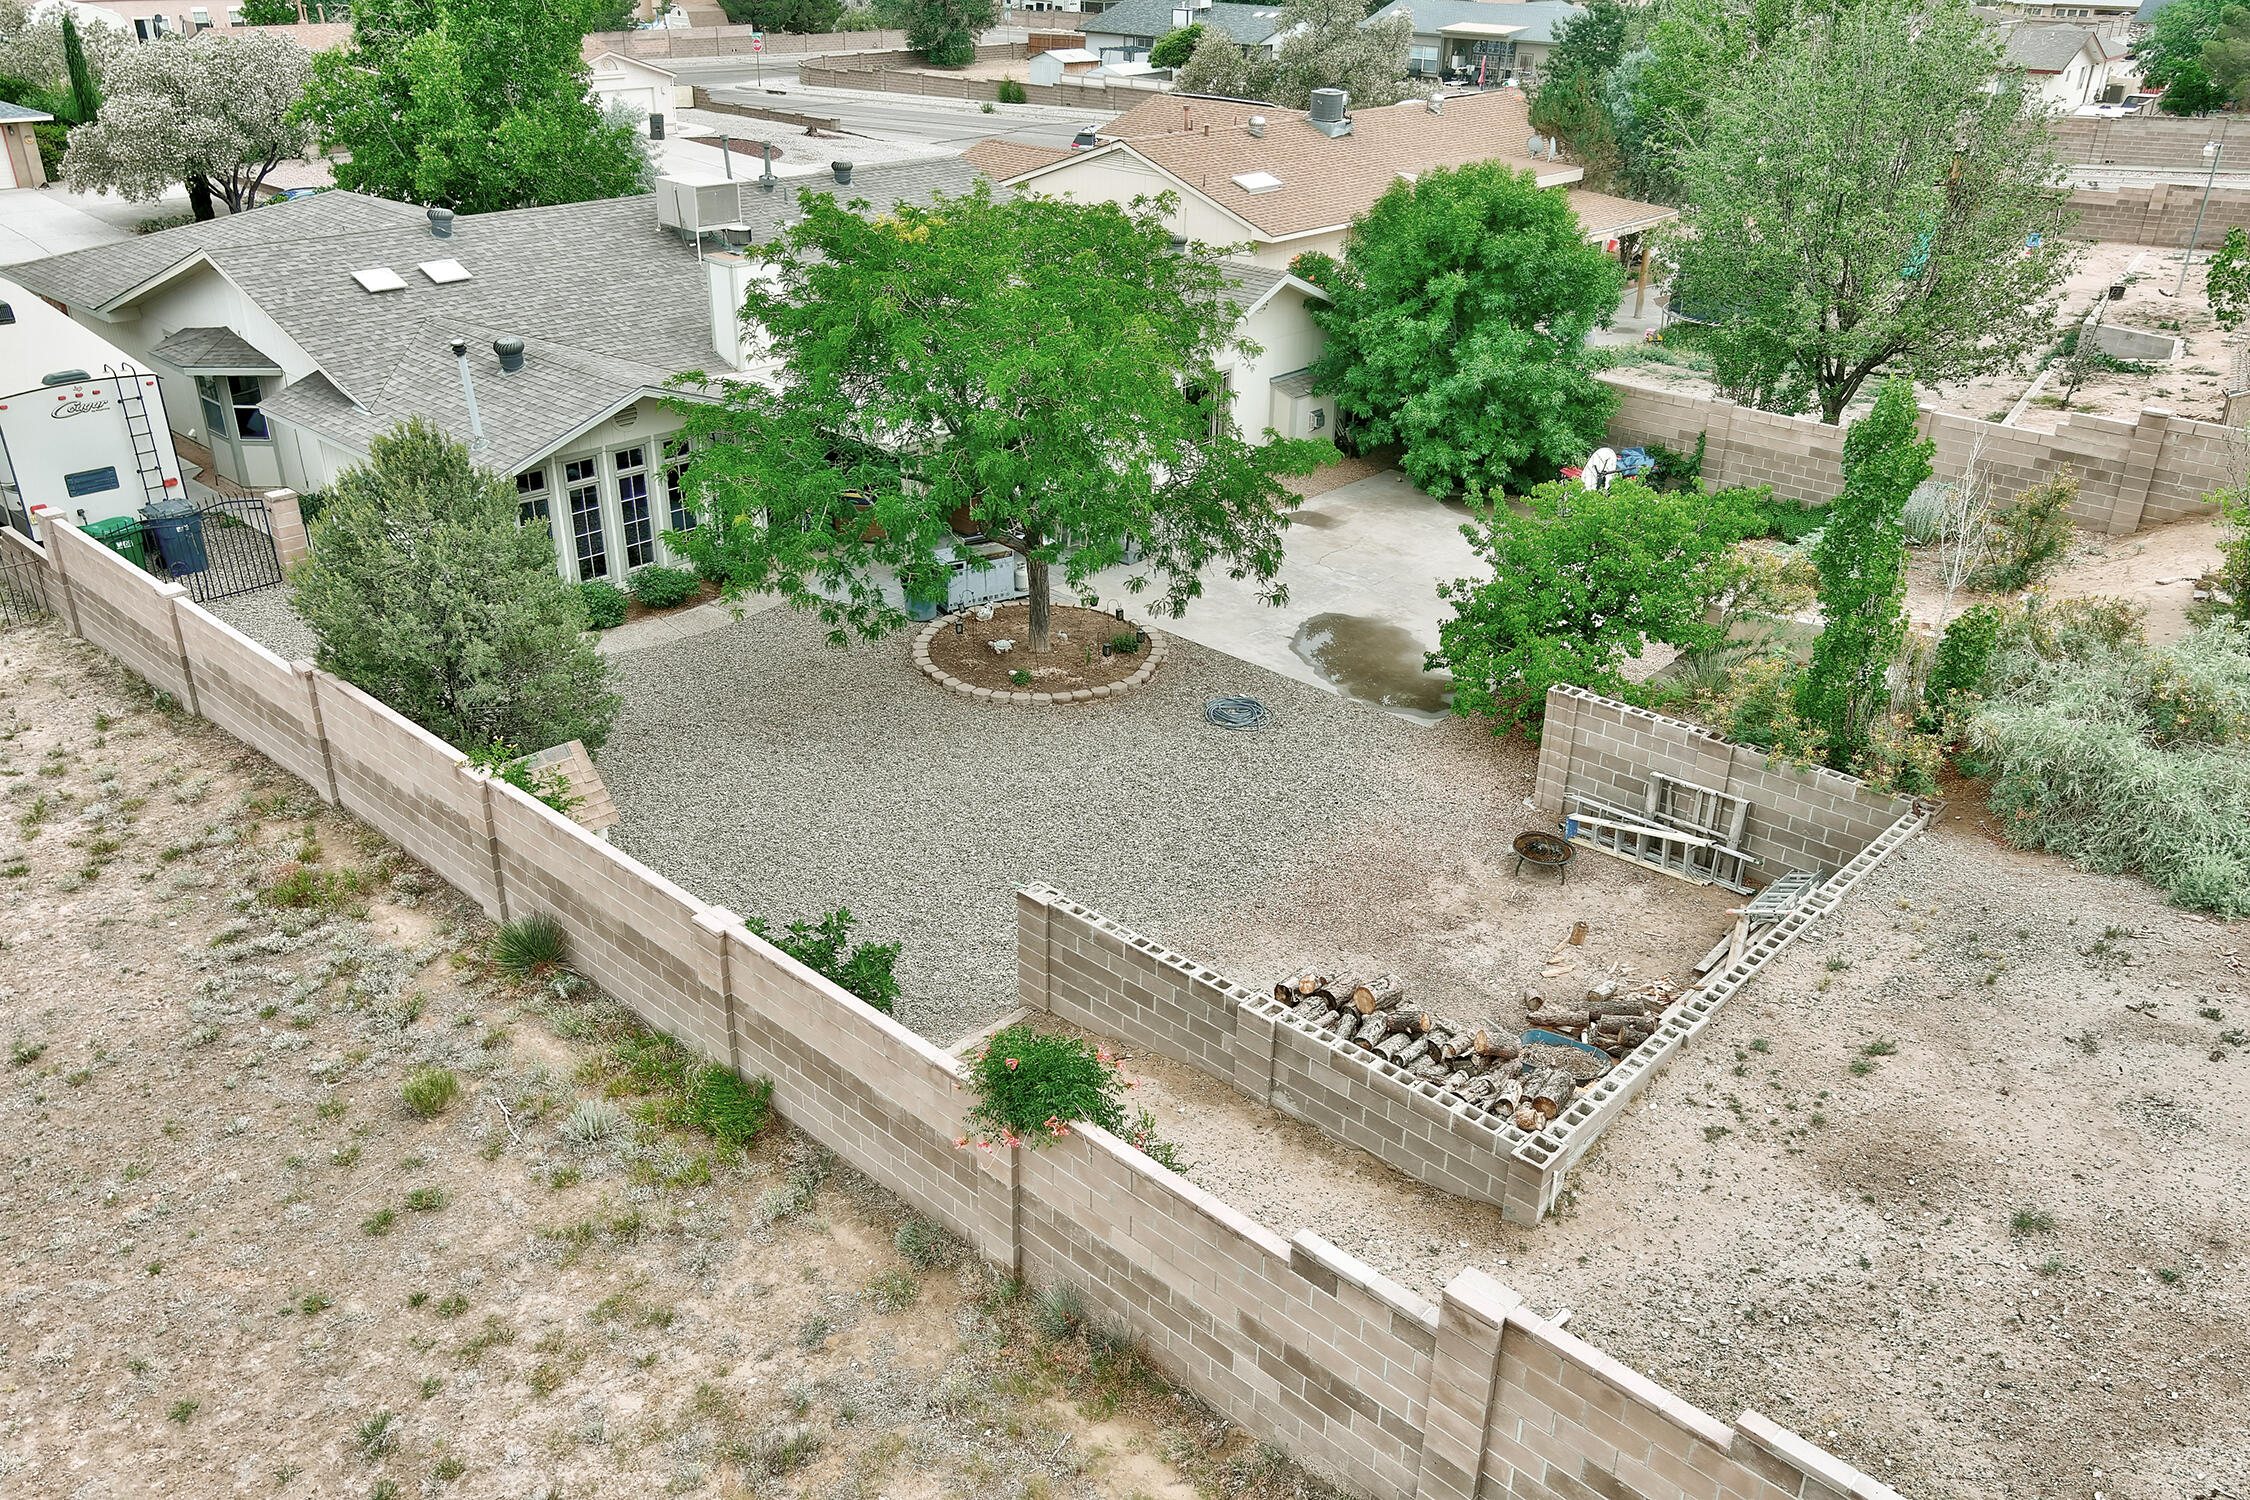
[{"xmin": 1532, "ymin": 686, "xmax": 1913, "ymax": 884}]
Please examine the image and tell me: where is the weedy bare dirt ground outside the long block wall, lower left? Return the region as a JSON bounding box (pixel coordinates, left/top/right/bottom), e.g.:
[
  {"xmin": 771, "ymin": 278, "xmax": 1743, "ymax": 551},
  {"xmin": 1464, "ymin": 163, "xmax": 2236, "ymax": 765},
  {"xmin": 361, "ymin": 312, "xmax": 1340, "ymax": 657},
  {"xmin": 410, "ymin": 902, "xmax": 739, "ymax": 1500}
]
[{"xmin": 0, "ymin": 625, "xmax": 1314, "ymax": 1500}]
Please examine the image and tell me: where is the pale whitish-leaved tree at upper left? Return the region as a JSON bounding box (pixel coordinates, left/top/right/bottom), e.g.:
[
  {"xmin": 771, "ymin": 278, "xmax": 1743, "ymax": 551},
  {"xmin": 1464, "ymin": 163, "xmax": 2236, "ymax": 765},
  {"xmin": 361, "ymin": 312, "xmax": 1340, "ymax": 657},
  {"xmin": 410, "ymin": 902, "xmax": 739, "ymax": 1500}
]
[{"xmin": 63, "ymin": 31, "xmax": 313, "ymax": 218}]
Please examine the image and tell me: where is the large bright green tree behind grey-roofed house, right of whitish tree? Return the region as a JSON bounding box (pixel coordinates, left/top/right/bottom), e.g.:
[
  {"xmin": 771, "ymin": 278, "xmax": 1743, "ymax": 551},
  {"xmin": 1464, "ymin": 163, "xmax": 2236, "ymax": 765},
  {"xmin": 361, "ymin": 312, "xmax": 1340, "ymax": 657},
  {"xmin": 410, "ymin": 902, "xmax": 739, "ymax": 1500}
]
[{"xmin": 302, "ymin": 0, "xmax": 646, "ymax": 214}]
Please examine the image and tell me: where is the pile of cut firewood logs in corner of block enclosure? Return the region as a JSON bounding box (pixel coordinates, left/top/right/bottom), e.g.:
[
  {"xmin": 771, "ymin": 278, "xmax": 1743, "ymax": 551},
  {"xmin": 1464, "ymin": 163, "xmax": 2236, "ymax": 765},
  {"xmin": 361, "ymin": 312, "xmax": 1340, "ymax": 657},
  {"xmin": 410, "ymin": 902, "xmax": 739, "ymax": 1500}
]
[{"xmin": 1274, "ymin": 969, "xmax": 1676, "ymax": 1131}]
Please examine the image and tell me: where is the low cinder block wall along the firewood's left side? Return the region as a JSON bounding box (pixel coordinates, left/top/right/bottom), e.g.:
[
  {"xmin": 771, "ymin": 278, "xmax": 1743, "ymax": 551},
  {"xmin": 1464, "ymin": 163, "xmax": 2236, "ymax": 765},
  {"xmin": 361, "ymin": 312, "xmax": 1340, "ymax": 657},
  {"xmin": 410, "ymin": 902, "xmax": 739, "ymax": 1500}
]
[{"xmin": 1015, "ymin": 886, "xmax": 1541, "ymax": 1223}]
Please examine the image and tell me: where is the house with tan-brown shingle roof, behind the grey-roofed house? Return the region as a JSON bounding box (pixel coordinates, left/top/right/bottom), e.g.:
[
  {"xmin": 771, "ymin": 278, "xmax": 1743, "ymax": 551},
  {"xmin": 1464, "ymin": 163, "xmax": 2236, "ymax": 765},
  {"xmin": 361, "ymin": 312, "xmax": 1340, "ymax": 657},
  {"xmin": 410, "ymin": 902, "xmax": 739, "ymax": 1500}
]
[{"xmin": 968, "ymin": 90, "xmax": 1676, "ymax": 270}]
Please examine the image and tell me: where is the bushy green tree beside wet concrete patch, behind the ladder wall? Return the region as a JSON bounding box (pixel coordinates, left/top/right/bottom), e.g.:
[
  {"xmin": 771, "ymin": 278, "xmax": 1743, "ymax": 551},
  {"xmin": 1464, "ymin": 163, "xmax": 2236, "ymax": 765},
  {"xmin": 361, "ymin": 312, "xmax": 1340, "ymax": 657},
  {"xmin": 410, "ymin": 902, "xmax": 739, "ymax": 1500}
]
[{"xmin": 1429, "ymin": 479, "xmax": 1757, "ymax": 740}]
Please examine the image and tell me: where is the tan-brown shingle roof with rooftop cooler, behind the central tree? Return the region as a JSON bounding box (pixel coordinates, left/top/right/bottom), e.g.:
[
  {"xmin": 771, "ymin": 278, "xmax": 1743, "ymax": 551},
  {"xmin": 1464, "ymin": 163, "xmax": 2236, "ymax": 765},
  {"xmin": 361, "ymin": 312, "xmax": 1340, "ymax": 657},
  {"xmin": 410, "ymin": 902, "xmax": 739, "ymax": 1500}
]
[{"xmin": 1057, "ymin": 90, "xmax": 1584, "ymax": 238}]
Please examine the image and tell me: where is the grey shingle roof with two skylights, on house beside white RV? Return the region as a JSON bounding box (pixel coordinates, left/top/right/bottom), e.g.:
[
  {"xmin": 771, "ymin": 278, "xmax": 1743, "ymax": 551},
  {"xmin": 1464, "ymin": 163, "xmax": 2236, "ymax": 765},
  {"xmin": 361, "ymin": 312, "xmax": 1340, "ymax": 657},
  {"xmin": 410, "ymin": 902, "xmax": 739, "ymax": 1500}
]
[{"xmin": 11, "ymin": 157, "xmax": 994, "ymax": 468}]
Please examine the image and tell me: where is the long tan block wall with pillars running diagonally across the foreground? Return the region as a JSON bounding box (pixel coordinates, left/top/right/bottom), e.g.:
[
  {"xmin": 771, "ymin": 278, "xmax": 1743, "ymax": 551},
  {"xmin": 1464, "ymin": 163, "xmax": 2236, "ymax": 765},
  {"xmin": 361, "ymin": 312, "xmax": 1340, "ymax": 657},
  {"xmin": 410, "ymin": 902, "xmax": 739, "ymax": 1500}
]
[{"xmin": 13, "ymin": 526, "xmax": 1895, "ymax": 1500}]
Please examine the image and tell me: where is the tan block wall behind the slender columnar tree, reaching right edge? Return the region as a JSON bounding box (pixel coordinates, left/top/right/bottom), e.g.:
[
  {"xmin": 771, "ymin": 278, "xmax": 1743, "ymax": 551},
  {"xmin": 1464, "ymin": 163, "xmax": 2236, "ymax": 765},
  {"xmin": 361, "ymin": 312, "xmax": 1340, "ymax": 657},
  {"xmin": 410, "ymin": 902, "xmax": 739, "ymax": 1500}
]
[{"xmin": 1604, "ymin": 376, "xmax": 2246, "ymax": 537}]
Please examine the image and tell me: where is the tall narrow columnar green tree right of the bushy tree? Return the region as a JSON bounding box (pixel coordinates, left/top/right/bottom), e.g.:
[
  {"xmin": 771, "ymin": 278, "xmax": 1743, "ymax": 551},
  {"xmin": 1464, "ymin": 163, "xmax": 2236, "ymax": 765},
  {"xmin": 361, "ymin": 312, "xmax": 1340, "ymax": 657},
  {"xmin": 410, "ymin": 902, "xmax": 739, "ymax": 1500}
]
[{"xmin": 1796, "ymin": 380, "xmax": 1937, "ymax": 769}]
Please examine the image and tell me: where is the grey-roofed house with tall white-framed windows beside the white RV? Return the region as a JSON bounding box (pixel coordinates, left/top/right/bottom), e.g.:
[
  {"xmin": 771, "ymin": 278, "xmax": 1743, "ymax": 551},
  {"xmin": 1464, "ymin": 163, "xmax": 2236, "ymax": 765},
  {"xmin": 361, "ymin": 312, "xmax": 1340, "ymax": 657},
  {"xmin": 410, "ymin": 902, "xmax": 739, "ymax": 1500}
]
[{"xmin": 9, "ymin": 157, "xmax": 977, "ymax": 580}]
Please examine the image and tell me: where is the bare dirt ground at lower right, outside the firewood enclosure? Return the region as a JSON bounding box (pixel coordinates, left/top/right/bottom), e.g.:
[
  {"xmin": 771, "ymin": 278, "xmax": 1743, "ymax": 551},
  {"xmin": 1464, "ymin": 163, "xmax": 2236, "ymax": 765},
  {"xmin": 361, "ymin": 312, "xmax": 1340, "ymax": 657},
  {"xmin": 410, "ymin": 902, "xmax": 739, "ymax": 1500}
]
[{"xmin": 1057, "ymin": 823, "xmax": 2250, "ymax": 1500}]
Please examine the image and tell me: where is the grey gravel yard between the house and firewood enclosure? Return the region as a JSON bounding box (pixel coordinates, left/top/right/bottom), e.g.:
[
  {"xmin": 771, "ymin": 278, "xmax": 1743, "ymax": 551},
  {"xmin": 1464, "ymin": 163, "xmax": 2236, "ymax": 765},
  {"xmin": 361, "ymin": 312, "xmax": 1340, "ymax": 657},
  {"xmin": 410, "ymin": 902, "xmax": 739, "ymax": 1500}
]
[{"xmin": 601, "ymin": 609, "xmax": 1733, "ymax": 1043}]
